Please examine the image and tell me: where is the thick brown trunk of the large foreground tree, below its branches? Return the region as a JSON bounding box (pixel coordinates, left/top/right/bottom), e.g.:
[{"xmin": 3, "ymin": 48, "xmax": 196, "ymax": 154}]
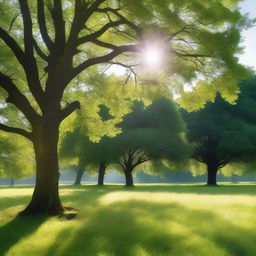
[{"xmin": 20, "ymin": 121, "xmax": 65, "ymax": 216}]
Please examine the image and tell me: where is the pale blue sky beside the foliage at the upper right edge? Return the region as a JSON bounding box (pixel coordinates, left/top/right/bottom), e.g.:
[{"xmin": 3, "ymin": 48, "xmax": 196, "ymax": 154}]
[{"xmin": 239, "ymin": 0, "xmax": 256, "ymax": 70}]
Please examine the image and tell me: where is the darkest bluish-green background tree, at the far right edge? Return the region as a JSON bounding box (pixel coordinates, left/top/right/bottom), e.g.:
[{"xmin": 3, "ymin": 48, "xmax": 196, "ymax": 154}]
[{"xmin": 182, "ymin": 79, "xmax": 256, "ymax": 185}]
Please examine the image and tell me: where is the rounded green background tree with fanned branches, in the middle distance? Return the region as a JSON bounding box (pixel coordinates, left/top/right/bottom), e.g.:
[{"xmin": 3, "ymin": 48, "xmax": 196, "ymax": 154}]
[{"xmin": 113, "ymin": 98, "xmax": 190, "ymax": 186}]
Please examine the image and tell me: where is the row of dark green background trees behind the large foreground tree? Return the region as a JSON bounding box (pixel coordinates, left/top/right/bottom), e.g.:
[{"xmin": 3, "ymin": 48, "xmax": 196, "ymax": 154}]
[{"xmin": 60, "ymin": 78, "xmax": 256, "ymax": 186}]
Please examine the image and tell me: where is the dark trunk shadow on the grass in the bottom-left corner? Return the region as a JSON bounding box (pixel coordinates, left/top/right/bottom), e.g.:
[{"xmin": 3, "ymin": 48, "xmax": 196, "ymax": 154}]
[{"xmin": 0, "ymin": 216, "xmax": 46, "ymax": 255}]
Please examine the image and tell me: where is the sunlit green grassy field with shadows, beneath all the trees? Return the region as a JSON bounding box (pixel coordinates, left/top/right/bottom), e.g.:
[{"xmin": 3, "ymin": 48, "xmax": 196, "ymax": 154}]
[{"xmin": 0, "ymin": 184, "xmax": 256, "ymax": 256}]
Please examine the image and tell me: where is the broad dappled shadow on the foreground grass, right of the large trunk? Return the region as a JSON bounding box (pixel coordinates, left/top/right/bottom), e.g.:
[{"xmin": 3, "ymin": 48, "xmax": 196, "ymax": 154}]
[{"xmin": 45, "ymin": 200, "xmax": 256, "ymax": 256}]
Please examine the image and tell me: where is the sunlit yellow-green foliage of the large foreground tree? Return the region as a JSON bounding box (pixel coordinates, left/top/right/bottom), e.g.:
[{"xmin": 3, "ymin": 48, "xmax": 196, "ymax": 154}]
[{"xmin": 0, "ymin": 0, "xmax": 252, "ymax": 140}]
